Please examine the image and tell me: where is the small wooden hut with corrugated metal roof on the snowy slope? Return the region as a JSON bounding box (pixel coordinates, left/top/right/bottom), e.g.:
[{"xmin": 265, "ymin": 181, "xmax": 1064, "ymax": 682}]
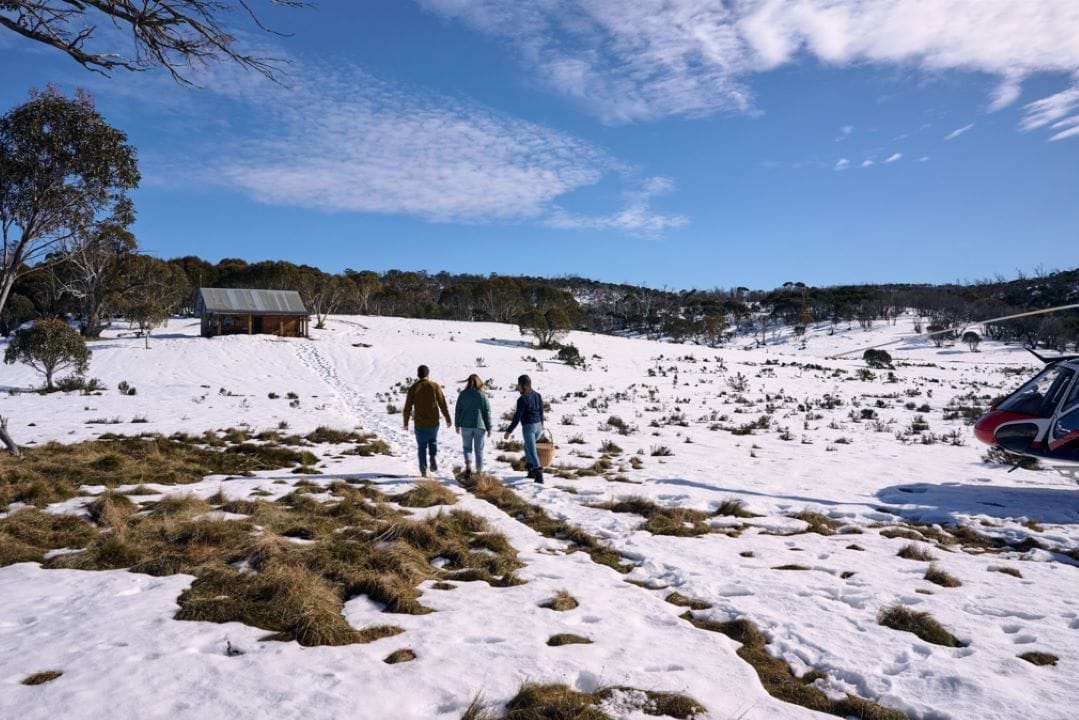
[{"xmin": 196, "ymin": 287, "xmax": 311, "ymax": 338}]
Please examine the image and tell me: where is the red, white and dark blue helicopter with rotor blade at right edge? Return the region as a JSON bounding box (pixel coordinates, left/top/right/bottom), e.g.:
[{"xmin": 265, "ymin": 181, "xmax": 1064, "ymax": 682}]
[{"xmin": 833, "ymin": 303, "xmax": 1079, "ymax": 481}]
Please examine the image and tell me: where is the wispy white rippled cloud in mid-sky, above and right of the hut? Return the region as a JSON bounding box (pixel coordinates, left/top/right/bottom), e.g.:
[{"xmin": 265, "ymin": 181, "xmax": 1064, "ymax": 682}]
[{"xmin": 153, "ymin": 63, "xmax": 687, "ymax": 233}]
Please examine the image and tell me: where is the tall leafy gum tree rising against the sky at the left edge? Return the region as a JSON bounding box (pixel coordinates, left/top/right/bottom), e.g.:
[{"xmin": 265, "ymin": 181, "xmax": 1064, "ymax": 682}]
[{"xmin": 0, "ymin": 87, "xmax": 139, "ymax": 321}]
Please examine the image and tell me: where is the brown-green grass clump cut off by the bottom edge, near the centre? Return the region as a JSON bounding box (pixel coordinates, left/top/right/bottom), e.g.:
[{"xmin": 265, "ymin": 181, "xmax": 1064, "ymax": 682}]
[{"xmin": 461, "ymin": 682, "xmax": 707, "ymax": 720}]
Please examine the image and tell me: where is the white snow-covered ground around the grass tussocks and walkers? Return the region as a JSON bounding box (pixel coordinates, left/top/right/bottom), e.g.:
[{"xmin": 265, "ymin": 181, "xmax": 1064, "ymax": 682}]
[{"xmin": 0, "ymin": 316, "xmax": 1079, "ymax": 720}]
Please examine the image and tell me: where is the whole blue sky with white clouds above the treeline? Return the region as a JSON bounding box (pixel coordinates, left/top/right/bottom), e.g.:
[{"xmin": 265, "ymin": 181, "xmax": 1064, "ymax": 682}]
[{"xmin": 0, "ymin": 0, "xmax": 1079, "ymax": 288}]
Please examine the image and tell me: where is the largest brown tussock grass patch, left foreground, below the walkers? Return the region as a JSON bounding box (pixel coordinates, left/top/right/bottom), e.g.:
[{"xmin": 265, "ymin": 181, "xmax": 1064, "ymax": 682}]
[{"xmin": 0, "ymin": 468, "xmax": 522, "ymax": 646}]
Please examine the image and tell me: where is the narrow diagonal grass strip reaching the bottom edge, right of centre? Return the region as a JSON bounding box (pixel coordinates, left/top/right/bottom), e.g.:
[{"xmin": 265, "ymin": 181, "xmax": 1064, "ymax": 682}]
[{"xmin": 681, "ymin": 610, "xmax": 906, "ymax": 720}]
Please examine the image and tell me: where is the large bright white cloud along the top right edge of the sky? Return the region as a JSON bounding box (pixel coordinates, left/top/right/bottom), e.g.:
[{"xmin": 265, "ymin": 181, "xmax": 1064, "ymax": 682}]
[{"xmin": 418, "ymin": 0, "xmax": 1079, "ymax": 122}]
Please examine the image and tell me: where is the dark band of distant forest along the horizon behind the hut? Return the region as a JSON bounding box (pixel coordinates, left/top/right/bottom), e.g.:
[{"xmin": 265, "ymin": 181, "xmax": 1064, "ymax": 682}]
[{"xmin": 8, "ymin": 253, "xmax": 1079, "ymax": 352}]
